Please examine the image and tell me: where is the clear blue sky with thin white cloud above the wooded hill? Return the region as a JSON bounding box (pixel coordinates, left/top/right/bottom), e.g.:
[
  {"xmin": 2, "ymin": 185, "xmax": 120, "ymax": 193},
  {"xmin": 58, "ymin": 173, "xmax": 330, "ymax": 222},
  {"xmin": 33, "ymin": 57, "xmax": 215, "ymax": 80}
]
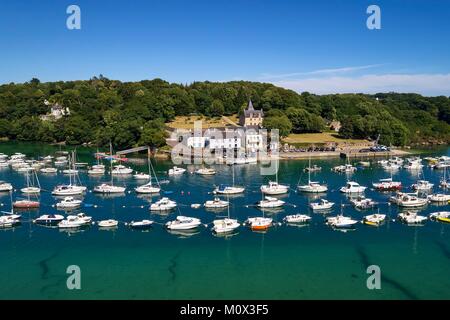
[{"xmin": 0, "ymin": 0, "xmax": 450, "ymax": 96}]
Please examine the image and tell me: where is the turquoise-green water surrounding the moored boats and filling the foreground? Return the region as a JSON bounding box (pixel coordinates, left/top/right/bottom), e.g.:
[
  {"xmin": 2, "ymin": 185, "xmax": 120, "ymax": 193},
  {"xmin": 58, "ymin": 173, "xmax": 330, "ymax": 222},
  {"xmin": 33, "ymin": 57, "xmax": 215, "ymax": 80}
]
[{"xmin": 0, "ymin": 144, "xmax": 450, "ymax": 299}]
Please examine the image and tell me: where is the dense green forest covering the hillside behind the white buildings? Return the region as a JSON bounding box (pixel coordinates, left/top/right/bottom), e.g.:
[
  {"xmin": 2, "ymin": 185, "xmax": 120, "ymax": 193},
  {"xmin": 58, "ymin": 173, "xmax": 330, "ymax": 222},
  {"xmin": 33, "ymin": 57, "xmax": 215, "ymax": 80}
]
[{"xmin": 0, "ymin": 76, "xmax": 450, "ymax": 148}]
